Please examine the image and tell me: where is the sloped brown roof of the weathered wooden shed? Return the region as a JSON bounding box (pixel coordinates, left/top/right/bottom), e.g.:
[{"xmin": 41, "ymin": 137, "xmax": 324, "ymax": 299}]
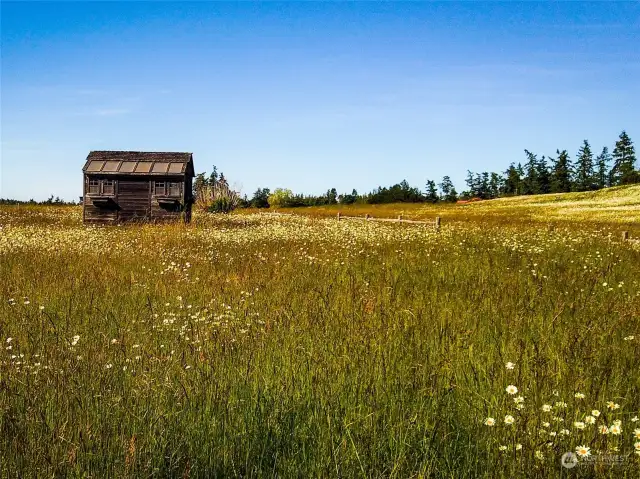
[{"xmin": 82, "ymin": 151, "xmax": 194, "ymax": 176}]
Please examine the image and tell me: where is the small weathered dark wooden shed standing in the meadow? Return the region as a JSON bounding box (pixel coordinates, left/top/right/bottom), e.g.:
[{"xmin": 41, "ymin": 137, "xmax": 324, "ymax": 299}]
[{"xmin": 82, "ymin": 151, "xmax": 195, "ymax": 224}]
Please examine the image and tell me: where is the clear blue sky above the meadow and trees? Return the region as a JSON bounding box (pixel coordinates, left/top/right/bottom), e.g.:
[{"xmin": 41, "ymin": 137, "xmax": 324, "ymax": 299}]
[{"xmin": 0, "ymin": 1, "xmax": 640, "ymax": 200}]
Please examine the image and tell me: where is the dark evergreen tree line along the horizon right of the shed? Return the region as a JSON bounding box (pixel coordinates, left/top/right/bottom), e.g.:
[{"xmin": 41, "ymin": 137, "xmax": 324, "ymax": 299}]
[{"xmin": 220, "ymin": 131, "xmax": 640, "ymax": 208}]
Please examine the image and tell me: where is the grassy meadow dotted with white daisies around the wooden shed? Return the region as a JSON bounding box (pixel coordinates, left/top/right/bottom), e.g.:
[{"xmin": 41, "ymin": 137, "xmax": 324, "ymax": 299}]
[{"xmin": 0, "ymin": 187, "xmax": 640, "ymax": 478}]
